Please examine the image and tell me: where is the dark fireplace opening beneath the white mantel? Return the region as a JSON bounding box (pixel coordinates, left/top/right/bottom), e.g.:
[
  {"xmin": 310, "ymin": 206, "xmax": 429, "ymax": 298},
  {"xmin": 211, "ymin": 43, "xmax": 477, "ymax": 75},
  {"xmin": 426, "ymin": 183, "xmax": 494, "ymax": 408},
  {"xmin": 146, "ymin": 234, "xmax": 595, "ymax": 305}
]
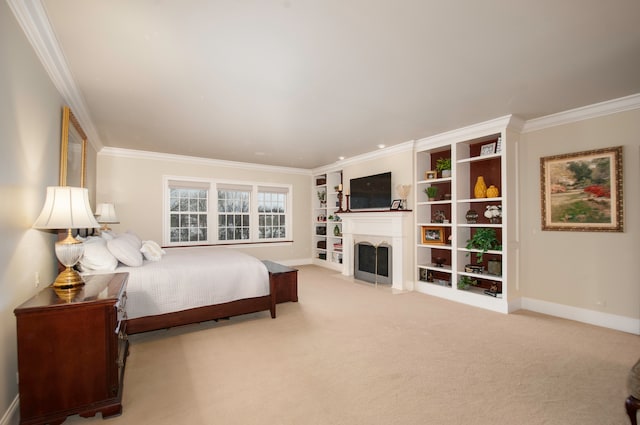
[{"xmin": 353, "ymin": 242, "xmax": 393, "ymax": 285}]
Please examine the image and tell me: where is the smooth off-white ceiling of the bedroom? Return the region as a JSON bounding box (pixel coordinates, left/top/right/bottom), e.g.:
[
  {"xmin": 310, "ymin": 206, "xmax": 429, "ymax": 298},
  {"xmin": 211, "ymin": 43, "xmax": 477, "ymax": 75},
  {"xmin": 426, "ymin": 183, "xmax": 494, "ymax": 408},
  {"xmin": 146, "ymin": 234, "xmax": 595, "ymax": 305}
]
[{"xmin": 31, "ymin": 0, "xmax": 640, "ymax": 168}]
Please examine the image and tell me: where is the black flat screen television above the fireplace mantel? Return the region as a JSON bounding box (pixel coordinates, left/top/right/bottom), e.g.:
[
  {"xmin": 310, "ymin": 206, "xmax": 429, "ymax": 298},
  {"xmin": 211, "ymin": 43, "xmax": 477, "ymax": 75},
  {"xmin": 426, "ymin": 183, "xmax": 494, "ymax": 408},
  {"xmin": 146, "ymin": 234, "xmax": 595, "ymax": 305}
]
[{"xmin": 349, "ymin": 171, "xmax": 391, "ymax": 210}]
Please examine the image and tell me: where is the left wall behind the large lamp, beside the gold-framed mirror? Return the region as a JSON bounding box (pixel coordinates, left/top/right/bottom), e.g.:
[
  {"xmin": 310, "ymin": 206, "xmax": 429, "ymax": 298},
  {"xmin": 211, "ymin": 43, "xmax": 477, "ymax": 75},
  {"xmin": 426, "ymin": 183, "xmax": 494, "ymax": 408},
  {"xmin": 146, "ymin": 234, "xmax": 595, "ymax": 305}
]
[{"xmin": 0, "ymin": 2, "xmax": 62, "ymax": 423}]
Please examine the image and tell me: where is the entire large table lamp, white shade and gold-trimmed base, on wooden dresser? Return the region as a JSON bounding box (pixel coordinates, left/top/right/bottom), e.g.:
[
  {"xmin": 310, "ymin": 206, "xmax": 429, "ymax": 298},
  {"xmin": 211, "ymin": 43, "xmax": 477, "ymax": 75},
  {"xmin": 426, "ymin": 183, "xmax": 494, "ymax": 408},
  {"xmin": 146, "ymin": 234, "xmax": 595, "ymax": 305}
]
[{"xmin": 33, "ymin": 186, "xmax": 100, "ymax": 290}]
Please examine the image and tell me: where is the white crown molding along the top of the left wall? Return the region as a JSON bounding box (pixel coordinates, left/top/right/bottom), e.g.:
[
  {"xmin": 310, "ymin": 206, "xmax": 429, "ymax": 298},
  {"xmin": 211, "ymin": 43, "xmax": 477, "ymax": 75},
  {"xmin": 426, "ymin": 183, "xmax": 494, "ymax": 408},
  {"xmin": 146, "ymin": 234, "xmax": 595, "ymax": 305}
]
[{"xmin": 7, "ymin": 0, "xmax": 103, "ymax": 152}]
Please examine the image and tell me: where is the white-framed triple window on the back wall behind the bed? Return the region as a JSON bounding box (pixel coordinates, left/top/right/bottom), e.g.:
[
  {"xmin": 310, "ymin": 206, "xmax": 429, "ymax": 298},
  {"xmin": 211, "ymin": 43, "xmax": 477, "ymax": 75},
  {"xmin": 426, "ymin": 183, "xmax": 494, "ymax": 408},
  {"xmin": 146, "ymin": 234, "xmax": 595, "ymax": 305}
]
[{"xmin": 163, "ymin": 177, "xmax": 292, "ymax": 245}]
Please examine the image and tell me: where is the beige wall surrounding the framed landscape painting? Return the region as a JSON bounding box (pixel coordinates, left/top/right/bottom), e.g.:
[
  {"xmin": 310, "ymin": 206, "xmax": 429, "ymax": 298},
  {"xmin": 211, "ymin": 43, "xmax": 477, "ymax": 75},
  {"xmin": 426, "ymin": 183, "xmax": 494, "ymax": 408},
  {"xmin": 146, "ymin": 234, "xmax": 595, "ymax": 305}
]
[{"xmin": 519, "ymin": 109, "xmax": 640, "ymax": 332}]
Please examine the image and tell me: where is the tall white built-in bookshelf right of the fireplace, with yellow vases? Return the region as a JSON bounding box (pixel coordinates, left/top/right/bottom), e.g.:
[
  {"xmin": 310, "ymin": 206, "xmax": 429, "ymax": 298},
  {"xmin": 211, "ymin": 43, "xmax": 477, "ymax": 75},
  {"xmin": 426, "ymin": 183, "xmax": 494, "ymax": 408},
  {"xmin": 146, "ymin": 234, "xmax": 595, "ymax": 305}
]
[{"xmin": 414, "ymin": 116, "xmax": 521, "ymax": 313}]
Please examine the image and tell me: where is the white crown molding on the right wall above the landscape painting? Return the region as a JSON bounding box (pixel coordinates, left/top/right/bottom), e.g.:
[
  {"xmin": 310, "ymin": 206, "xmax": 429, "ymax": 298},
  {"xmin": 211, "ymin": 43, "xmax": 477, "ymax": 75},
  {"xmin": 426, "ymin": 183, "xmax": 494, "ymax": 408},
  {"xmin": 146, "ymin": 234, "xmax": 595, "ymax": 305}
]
[{"xmin": 522, "ymin": 93, "xmax": 640, "ymax": 133}]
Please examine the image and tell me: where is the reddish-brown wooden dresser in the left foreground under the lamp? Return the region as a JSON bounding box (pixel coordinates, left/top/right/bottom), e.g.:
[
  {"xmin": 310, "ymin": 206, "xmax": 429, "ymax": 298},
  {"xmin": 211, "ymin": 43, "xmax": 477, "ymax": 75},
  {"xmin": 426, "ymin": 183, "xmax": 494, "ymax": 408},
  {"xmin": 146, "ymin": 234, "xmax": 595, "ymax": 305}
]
[{"xmin": 14, "ymin": 273, "xmax": 129, "ymax": 424}]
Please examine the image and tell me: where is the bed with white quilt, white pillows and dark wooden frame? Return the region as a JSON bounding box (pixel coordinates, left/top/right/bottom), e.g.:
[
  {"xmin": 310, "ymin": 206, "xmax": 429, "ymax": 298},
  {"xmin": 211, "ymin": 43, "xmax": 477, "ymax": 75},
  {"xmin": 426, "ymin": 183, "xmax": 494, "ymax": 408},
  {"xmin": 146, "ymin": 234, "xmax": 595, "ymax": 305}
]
[{"xmin": 81, "ymin": 234, "xmax": 276, "ymax": 334}]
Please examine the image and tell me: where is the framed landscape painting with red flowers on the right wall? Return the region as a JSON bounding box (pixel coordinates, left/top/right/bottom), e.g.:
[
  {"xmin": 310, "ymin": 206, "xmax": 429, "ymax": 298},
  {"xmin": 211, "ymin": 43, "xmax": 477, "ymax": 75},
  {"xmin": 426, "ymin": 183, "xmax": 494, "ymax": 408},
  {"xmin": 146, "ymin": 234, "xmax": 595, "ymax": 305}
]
[{"xmin": 540, "ymin": 146, "xmax": 623, "ymax": 232}]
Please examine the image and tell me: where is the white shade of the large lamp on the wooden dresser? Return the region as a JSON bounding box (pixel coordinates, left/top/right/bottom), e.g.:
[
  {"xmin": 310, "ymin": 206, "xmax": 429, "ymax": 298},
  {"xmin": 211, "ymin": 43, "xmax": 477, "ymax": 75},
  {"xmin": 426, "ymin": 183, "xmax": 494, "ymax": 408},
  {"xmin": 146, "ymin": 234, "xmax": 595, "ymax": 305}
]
[{"xmin": 33, "ymin": 186, "xmax": 100, "ymax": 229}]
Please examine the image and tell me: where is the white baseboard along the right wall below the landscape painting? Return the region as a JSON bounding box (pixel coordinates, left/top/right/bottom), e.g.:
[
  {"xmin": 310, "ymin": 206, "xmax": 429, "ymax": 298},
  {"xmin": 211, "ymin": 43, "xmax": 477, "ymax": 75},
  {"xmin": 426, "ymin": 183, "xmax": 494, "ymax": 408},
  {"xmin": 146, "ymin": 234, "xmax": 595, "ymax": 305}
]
[{"xmin": 521, "ymin": 298, "xmax": 640, "ymax": 335}]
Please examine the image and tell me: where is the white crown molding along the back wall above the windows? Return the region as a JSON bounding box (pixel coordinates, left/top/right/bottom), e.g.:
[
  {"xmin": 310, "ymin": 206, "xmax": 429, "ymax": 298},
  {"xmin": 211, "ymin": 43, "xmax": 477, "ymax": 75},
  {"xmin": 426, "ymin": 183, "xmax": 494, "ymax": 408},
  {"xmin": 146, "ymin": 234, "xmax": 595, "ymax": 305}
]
[{"xmin": 98, "ymin": 147, "xmax": 311, "ymax": 176}]
